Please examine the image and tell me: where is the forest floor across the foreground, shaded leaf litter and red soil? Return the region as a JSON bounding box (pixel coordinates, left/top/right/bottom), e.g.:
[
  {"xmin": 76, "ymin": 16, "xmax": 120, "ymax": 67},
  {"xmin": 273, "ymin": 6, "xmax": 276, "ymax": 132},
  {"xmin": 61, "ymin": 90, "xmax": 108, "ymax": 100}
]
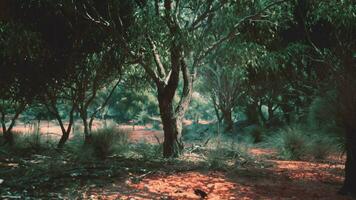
[{"xmin": 0, "ymin": 122, "xmax": 348, "ymax": 200}]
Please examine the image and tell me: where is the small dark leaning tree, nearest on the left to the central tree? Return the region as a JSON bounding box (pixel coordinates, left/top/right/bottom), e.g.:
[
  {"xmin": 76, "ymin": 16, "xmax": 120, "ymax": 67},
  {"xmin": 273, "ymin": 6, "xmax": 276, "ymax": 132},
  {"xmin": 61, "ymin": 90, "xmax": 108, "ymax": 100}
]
[{"xmin": 74, "ymin": 49, "xmax": 123, "ymax": 143}]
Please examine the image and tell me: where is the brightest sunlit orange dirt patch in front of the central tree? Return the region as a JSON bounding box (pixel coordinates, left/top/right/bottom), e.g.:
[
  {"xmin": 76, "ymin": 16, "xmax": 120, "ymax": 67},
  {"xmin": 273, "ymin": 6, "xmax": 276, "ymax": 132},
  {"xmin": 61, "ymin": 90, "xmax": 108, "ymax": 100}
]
[{"xmin": 130, "ymin": 172, "xmax": 250, "ymax": 200}]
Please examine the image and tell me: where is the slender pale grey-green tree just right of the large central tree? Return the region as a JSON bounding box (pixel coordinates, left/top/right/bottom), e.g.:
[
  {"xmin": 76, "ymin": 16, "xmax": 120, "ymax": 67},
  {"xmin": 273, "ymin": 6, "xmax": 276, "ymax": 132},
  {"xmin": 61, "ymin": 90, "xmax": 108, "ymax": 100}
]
[{"xmin": 203, "ymin": 42, "xmax": 246, "ymax": 132}]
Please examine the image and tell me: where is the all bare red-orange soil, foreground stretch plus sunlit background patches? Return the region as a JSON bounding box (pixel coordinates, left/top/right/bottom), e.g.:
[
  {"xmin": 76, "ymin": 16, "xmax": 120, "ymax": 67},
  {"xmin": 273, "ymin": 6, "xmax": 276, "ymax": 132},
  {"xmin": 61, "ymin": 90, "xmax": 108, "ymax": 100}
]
[{"xmin": 6, "ymin": 123, "xmax": 348, "ymax": 200}]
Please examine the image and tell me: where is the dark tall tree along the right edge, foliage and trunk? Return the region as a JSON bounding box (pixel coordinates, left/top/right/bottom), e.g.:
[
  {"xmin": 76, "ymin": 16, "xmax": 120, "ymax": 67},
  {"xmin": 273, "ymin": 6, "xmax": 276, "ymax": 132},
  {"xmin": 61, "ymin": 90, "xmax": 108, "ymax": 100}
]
[{"xmin": 297, "ymin": 1, "xmax": 356, "ymax": 197}]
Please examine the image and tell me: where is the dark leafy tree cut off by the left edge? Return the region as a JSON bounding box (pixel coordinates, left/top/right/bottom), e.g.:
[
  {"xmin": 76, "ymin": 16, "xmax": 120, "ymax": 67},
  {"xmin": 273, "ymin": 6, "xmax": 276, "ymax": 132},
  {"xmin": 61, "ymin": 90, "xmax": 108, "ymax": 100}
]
[{"xmin": 0, "ymin": 21, "xmax": 44, "ymax": 145}]
